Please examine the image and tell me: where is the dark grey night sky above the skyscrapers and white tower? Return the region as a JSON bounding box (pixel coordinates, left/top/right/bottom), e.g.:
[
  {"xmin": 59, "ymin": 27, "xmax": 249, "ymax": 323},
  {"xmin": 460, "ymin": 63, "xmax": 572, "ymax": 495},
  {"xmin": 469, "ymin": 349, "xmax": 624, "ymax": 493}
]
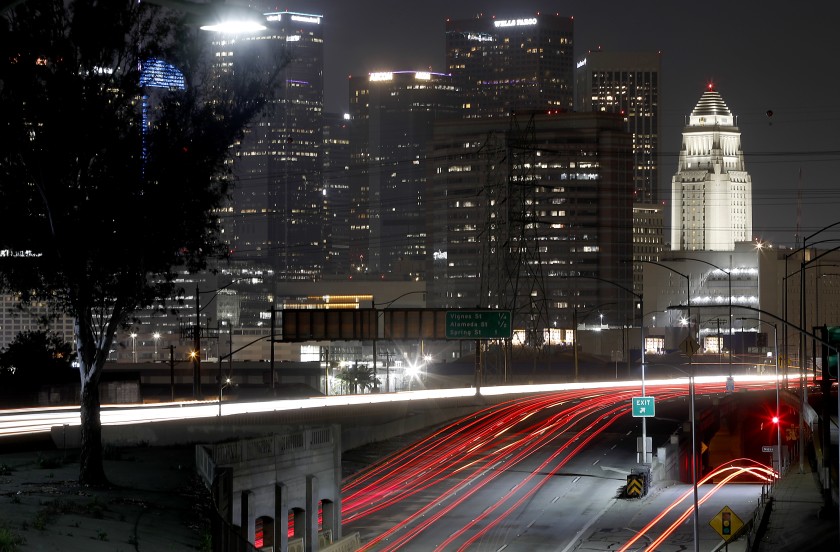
[{"xmin": 278, "ymin": 0, "xmax": 840, "ymax": 246}]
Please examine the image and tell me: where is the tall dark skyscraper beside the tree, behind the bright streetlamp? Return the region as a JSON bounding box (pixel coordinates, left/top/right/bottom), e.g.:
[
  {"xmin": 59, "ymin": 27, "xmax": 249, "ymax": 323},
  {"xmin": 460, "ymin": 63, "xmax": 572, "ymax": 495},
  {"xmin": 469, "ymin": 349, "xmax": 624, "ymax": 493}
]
[{"xmin": 213, "ymin": 12, "xmax": 326, "ymax": 279}]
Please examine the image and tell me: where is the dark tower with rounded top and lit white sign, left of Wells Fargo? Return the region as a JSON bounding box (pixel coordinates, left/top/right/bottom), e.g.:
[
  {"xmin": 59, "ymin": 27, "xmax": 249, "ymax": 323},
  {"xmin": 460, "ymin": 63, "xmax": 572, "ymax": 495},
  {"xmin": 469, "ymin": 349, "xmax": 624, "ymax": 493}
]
[{"xmin": 350, "ymin": 71, "xmax": 461, "ymax": 279}]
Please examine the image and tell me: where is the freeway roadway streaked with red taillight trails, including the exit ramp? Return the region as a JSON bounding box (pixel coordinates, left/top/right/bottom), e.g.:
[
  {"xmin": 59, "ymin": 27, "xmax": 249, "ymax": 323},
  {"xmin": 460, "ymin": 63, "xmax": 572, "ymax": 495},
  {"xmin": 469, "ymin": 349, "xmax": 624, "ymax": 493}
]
[{"xmin": 342, "ymin": 382, "xmax": 772, "ymax": 551}]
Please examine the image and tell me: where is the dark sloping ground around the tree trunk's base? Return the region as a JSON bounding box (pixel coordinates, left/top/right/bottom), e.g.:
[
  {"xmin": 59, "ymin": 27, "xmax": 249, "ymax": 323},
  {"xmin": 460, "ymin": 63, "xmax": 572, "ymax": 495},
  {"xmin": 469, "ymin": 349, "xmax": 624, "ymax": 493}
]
[{"xmin": 0, "ymin": 443, "xmax": 205, "ymax": 552}]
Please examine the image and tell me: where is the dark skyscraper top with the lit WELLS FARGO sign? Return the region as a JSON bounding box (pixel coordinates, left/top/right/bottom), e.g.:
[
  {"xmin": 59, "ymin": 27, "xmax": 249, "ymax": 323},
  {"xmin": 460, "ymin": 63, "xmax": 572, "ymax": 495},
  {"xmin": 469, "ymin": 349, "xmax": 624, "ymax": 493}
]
[{"xmin": 446, "ymin": 14, "xmax": 574, "ymax": 118}]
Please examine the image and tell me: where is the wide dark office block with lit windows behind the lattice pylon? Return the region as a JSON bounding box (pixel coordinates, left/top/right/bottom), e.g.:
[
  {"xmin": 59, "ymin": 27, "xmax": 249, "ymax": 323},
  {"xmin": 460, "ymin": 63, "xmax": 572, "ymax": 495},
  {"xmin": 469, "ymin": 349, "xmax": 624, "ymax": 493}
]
[{"xmin": 427, "ymin": 113, "xmax": 633, "ymax": 333}]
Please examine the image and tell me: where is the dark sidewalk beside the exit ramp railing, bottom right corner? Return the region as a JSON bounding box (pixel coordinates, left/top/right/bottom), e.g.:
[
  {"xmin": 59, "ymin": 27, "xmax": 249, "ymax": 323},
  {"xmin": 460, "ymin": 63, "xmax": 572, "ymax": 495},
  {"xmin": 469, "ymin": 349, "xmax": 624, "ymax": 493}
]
[{"xmin": 756, "ymin": 462, "xmax": 840, "ymax": 552}]
